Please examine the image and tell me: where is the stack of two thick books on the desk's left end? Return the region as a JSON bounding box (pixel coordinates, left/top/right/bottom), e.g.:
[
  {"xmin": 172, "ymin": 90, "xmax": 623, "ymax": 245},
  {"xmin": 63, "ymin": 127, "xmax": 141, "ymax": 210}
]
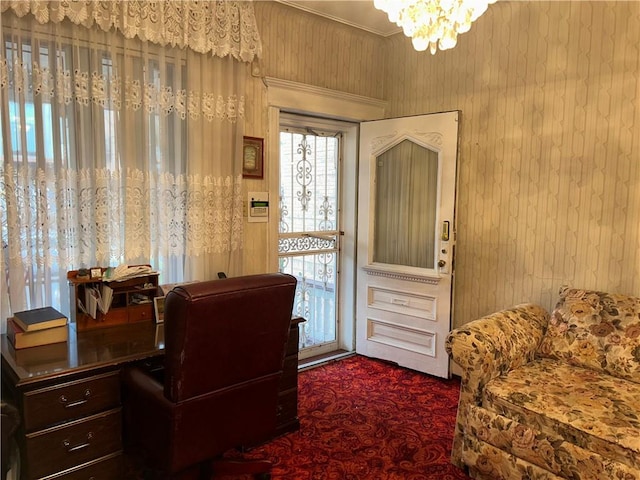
[{"xmin": 7, "ymin": 307, "xmax": 69, "ymax": 350}]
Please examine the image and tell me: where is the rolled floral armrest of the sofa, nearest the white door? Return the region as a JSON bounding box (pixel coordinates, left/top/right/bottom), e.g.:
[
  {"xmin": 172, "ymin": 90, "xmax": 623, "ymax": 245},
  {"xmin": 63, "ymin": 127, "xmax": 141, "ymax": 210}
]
[{"xmin": 445, "ymin": 303, "xmax": 549, "ymax": 466}]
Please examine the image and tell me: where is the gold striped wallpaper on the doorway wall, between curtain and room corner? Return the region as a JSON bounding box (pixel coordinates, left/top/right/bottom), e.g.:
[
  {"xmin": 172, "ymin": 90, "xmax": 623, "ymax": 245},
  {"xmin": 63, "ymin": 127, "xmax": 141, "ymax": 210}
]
[{"xmin": 243, "ymin": 1, "xmax": 385, "ymax": 274}]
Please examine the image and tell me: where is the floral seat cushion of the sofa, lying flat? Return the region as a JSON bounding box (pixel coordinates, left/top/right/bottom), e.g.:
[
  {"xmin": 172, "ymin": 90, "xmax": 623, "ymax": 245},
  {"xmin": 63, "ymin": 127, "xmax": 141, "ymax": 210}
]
[{"xmin": 483, "ymin": 358, "xmax": 640, "ymax": 469}]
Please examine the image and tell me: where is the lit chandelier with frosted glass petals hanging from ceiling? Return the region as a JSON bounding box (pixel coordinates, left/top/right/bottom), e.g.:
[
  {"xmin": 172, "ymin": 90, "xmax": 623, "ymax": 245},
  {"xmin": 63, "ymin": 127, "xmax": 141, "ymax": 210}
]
[{"xmin": 373, "ymin": 0, "xmax": 496, "ymax": 54}]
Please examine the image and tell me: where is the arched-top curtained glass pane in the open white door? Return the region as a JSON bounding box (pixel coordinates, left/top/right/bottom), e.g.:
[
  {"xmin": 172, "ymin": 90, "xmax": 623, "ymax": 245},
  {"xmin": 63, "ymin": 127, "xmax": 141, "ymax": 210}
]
[{"xmin": 373, "ymin": 140, "xmax": 438, "ymax": 269}]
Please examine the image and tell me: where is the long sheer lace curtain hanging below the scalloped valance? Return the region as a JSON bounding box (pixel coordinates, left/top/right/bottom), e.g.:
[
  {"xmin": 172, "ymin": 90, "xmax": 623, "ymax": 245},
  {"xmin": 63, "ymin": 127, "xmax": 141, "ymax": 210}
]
[{"xmin": 0, "ymin": 7, "xmax": 249, "ymax": 329}]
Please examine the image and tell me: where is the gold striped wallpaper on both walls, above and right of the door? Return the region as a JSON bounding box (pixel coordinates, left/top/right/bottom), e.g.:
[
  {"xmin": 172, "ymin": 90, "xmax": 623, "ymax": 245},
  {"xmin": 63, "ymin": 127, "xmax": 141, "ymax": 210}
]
[{"xmin": 247, "ymin": 1, "xmax": 640, "ymax": 325}]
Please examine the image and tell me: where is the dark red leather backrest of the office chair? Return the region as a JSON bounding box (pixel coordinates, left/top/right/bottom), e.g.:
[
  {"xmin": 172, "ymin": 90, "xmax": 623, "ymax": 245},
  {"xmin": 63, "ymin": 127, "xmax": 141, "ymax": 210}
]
[{"xmin": 164, "ymin": 273, "xmax": 296, "ymax": 402}]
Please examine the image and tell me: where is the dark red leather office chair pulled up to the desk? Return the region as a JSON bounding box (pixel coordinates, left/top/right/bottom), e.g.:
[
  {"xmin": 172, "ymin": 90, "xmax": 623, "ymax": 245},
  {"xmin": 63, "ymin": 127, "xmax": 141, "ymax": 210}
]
[{"xmin": 123, "ymin": 273, "xmax": 296, "ymax": 478}]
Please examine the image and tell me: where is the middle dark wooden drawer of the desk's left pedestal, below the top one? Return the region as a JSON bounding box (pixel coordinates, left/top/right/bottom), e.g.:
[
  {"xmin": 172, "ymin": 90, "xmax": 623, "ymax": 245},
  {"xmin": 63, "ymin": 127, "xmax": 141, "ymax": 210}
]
[{"xmin": 25, "ymin": 408, "xmax": 122, "ymax": 479}]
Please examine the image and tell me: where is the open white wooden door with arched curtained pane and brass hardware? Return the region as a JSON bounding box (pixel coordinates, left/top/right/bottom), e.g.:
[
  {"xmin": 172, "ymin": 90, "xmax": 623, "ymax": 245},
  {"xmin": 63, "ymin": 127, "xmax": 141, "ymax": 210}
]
[{"xmin": 356, "ymin": 111, "xmax": 459, "ymax": 378}]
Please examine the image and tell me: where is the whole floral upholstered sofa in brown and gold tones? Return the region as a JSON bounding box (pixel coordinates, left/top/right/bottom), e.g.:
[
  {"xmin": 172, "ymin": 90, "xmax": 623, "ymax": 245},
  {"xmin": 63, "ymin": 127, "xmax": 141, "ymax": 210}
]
[{"xmin": 446, "ymin": 287, "xmax": 640, "ymax": 480}]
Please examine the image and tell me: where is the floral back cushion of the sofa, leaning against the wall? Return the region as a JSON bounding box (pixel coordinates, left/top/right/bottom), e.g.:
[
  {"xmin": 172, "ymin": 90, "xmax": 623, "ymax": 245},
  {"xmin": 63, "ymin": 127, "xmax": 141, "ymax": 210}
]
[{"xmin": 538, "ymin": 287, "xmax": 640, "ymax": 383}]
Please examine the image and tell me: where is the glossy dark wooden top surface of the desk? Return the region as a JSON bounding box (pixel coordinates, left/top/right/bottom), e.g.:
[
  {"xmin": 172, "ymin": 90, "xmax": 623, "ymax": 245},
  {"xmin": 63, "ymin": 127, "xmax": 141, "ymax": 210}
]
[{"xmin": 0, "ymin": 322, "xmax": 164, "ymax": 387}]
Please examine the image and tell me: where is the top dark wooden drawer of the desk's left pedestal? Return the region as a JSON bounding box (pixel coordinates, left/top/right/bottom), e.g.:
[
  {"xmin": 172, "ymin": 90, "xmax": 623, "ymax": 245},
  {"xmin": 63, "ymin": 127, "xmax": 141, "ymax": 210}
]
[{"xmin": 23, "ymin": 372, "xmax": 120, "ymax": 432}]
